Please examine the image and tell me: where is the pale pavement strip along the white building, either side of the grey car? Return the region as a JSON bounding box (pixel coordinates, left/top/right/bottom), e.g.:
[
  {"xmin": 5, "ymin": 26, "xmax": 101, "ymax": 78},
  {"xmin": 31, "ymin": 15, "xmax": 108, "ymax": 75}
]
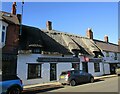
[{"xmin": 23, "ymin": 75, "xmax": 117, "ymax": 92}]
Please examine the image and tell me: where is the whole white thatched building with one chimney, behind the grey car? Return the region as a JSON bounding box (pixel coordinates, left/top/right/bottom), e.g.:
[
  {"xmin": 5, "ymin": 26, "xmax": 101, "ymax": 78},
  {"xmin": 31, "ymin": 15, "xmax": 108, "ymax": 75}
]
[{"xmin": 17, "ymin": 21, "xmax": 103, "ymax": 85}]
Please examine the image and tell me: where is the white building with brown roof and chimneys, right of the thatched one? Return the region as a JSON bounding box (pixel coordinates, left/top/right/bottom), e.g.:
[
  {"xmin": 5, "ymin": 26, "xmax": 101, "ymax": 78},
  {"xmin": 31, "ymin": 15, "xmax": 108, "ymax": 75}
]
[{"xmin": 87, "ymin": 29, "xmax": 120, "ymax": 74}]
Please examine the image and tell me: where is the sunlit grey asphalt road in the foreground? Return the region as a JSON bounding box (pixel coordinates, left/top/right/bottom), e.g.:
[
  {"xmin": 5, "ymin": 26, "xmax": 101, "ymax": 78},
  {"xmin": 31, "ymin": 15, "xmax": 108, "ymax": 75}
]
[{"xmin": 23, "ymin": 77, "xmax": 120, "ymax": 94}]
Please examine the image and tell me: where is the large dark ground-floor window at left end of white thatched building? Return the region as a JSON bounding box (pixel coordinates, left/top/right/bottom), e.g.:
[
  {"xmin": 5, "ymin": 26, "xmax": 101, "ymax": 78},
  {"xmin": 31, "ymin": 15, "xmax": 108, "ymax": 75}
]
[{"xmin": 28, "ymin": 64, "xmax": 41, "ymax": 79}]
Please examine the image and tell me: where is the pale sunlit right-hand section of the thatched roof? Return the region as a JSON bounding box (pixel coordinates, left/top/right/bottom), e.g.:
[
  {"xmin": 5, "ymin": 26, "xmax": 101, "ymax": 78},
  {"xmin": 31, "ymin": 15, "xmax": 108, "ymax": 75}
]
[{"xmin": 41, "ymin": 30, "xmax": 103, "ymax": 56}]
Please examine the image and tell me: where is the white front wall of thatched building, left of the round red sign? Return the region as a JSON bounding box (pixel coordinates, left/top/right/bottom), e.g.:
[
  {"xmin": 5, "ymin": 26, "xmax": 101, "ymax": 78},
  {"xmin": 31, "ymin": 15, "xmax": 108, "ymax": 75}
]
[{"xmin": 17, "ymin": 54, "xmax": 77, "ymax": 85}]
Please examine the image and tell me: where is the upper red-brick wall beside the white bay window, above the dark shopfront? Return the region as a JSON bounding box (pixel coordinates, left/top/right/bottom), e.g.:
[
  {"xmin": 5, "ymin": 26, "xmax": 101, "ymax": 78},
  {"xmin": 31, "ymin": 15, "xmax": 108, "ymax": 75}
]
[{"xmin": 2, "ymin": 24, "xmax": 19, "ymax": 54}]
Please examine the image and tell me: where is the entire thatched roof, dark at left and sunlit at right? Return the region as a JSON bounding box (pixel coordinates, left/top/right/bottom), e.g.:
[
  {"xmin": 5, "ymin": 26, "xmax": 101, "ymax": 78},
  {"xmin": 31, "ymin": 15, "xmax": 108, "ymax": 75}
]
[{"xmin": 20, "ymin": 25, "xmax": 102, "ymax": 56}]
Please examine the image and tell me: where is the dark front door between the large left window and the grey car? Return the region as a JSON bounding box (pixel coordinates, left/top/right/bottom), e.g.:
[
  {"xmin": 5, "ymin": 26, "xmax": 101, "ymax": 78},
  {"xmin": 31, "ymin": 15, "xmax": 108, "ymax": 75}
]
[{"xmin": 50, "ymin": 63, "xmax": 57, "ymax": 81}]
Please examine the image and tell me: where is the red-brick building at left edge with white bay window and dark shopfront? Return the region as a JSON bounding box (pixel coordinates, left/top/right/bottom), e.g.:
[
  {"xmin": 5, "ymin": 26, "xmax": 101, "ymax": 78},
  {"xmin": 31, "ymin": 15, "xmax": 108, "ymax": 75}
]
[{"xmin": 0, "ymin": 8, "xmax": 20, "ymax": 75}]
